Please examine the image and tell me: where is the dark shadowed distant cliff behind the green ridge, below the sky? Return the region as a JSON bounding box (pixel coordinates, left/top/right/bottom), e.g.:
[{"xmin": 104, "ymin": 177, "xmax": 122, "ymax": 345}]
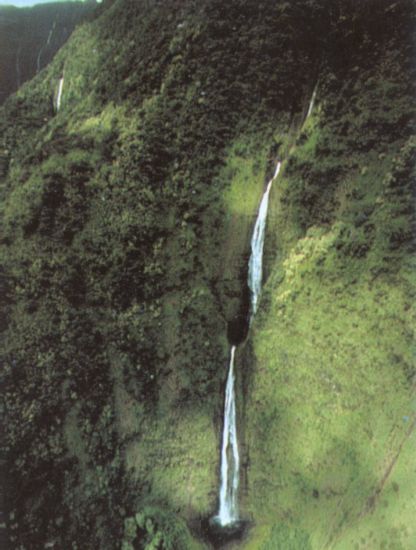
[{"xmin": 0, "ymin": 2, "xmax": 95, "ymax": 105}]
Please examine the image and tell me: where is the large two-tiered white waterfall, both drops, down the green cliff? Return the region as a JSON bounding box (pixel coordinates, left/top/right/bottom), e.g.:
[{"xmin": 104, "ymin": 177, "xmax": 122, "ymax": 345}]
[{"xmin": 215, "ymin": 161, "xmax": 281, "ymax": 527}]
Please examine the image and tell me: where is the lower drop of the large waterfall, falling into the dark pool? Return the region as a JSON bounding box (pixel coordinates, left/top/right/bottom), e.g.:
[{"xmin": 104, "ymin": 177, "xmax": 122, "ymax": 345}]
[{"xmin": 217, "ymin": 346, "xmax": 240, "ymax": 526}]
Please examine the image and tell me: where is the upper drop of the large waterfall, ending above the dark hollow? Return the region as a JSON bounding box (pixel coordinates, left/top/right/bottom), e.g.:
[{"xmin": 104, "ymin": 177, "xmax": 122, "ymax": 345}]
[{"xmin": 248, "ymin": 161, "xmax": 282, "ymax": 323}]
